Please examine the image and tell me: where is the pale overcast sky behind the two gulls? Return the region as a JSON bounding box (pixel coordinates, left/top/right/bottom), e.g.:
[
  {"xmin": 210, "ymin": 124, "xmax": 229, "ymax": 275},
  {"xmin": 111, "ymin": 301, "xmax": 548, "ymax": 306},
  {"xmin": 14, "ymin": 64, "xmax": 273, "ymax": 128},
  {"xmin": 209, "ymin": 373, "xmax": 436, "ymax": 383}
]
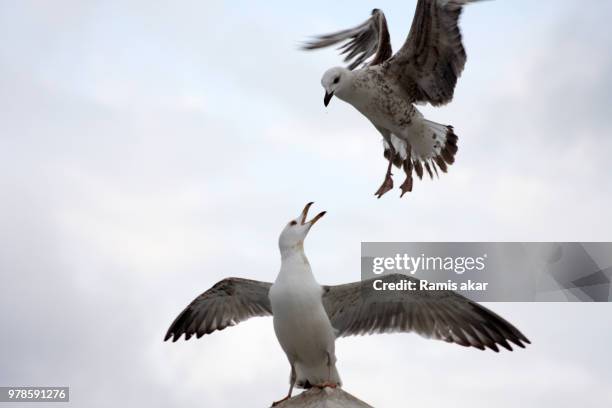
[{"xmin": 0, "ymin": 0, "xmax": 612, "ymax": 408}]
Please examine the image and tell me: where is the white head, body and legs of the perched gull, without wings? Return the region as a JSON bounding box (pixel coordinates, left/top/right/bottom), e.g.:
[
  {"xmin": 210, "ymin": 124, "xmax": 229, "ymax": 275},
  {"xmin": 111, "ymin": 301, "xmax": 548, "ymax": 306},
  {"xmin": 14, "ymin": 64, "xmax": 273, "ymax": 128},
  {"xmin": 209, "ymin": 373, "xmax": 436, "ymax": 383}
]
[{"xmin": 269, "ymin": 203, "xmax": 341, "ymax": 402}]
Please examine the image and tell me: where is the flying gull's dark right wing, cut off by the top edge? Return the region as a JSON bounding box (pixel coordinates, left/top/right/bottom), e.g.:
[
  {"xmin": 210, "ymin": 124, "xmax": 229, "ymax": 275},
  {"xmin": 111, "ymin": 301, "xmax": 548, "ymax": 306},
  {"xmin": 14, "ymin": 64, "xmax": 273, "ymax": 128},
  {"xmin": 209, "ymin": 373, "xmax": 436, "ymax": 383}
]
[{"xmin": 389, "ymin": 0, "xmax": 479, "ymax": 106}]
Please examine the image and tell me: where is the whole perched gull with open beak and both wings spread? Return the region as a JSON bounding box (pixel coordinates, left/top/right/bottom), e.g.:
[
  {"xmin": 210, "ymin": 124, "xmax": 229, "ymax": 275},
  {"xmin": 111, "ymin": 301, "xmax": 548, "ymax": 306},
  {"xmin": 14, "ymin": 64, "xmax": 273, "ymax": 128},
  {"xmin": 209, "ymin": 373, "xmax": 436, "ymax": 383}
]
[{"xmin": 164, "ymin": 203, "xmax": 530, "ymax": 406}]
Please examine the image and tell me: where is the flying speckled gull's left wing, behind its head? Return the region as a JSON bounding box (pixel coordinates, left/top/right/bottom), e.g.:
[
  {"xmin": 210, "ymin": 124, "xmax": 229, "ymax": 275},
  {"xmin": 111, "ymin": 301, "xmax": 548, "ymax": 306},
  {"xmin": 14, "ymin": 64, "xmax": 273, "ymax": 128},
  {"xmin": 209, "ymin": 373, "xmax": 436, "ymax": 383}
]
[{"xmin": 302, "ymin": 9, "xmax": 392, "ymax": 70}]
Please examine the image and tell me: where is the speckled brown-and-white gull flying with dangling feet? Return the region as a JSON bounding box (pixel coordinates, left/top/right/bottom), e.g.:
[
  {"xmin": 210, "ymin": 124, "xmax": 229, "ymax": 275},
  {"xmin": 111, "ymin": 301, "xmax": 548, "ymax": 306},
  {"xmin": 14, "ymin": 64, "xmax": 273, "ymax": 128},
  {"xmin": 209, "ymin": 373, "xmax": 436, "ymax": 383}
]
[{"xmin": 303, "ymin": 0, "xmax": 478, "ymax": 198}]
